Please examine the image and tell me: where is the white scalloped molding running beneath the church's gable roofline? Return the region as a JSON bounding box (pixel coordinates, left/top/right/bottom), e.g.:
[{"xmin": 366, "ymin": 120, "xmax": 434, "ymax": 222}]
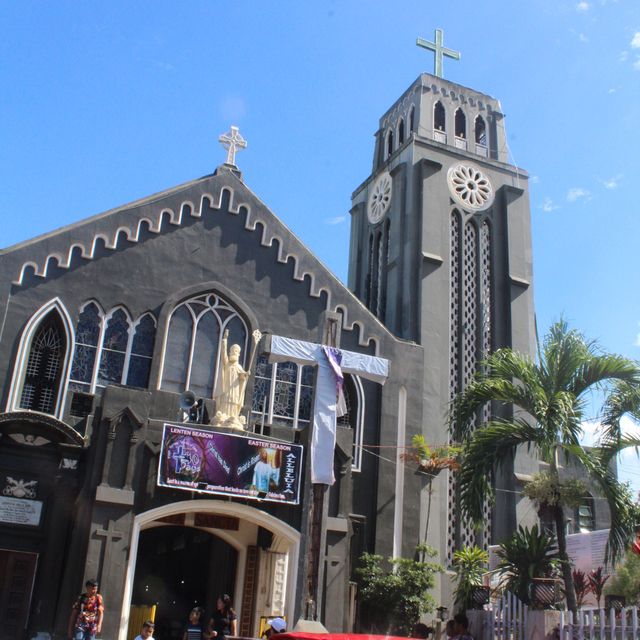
[{"xmin": 13, "ymin": 181, "xmax": 392, "ymax": 355}]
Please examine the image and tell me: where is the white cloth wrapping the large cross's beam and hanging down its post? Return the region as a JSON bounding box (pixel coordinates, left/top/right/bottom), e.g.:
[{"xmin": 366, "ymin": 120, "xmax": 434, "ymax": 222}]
[{"xmin": 269, "ymin": 336, "xmax": 389, "ymax": 485}]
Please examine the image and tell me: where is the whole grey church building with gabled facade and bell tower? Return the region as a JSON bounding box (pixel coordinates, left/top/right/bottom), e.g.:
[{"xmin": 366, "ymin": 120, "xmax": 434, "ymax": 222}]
[{"xmin": 0, "ymin": 33, "xmax": 537, "ymax": 640}]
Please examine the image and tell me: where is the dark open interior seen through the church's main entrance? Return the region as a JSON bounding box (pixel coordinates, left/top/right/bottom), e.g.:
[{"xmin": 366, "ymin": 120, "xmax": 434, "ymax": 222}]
[{"xmin": 129, "ymin": 525, "xmax": 237, "ymax": 640}]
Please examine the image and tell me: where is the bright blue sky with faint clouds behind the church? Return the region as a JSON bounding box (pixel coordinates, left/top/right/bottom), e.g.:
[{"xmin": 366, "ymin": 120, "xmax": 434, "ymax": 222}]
[{"xmin": 0, "ymin": 0, "xmax": 640, "ymax": 488}]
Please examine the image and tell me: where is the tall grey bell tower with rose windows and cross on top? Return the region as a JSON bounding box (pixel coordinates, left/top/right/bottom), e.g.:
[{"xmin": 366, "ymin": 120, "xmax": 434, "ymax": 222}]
[{"xmin": 349, "ymin": 32, "xmax": 535, "ymax": 563}]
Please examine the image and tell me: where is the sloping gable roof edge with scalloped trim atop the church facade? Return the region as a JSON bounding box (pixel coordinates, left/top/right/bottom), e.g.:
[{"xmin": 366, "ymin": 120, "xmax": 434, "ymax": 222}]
[{"xmin": 0, "ymin": 165, "xmax": 404, "ymax": 353}]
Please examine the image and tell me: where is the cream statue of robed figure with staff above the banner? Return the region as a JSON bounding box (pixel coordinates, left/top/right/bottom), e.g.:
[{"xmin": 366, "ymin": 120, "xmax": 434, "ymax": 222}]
[{"xmin": 213, "ymin": 329, "xmax": 262, "ymax": 429}]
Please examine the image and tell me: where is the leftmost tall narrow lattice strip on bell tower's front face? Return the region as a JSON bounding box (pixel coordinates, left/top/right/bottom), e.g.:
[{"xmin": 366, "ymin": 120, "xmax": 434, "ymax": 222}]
[{"xmin": 447, "ymin": 211, "xmax": 460, "ymax": 566}]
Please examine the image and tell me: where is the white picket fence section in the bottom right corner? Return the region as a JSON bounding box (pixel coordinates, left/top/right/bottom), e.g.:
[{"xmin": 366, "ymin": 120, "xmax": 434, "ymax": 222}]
[{"xmin": 560, "ymin": 607, "xmax": 640, "ymax": 640}]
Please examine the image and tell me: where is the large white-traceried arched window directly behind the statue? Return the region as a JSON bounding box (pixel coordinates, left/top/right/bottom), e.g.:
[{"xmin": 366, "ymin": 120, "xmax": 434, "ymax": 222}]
[{"xmin": 160, "ymin": 293, "xmax": 248, "ymax": 398}]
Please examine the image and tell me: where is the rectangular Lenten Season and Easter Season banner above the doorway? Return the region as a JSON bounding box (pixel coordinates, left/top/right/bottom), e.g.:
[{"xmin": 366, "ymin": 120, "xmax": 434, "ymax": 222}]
[{"xmin": 158, "ymin": 424, "xmax": 302, "ymax": 504}]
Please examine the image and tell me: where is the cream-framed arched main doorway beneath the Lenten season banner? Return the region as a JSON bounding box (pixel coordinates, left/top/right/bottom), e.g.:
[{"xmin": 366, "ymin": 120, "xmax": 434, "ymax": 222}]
[{"xmin": 117, "ymin": 499, "xmax": 300, "ymax": 640}]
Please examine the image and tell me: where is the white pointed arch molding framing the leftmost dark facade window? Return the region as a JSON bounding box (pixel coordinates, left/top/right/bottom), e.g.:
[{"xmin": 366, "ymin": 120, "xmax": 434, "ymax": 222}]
[{"xmin": 5, "ymin": 298, "xmax": 75, "ymax": 418}]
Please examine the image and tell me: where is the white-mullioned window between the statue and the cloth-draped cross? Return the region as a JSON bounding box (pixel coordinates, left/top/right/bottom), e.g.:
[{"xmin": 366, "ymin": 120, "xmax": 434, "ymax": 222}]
[{"xmin": 251, "ymin": 355, "xmax": 314, "ymax": 428}]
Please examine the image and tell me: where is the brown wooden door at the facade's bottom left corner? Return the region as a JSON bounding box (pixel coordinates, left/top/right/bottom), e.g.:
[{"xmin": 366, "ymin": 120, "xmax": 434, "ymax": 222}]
[{"xmin": 0, "ymin": 549, "xmax": 38, "ymax": 640}]
